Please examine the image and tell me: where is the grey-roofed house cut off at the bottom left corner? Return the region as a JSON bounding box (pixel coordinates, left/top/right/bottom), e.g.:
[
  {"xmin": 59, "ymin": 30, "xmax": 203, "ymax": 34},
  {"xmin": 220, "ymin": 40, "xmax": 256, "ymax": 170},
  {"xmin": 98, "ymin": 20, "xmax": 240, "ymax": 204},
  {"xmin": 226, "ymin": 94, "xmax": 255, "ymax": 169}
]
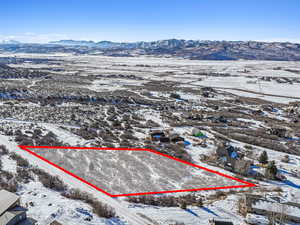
[{"xmin": 0, "ymin": 190, "xmax": 35, "ymax": 225}]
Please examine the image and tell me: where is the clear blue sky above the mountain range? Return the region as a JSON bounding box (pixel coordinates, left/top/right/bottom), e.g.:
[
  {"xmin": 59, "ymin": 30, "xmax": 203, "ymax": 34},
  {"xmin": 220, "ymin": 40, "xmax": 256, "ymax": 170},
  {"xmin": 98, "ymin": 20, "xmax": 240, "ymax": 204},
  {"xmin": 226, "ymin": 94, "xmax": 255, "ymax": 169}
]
[{"xmin": 0, "ymin": 0, "xmax": 300, "ymax": 43}]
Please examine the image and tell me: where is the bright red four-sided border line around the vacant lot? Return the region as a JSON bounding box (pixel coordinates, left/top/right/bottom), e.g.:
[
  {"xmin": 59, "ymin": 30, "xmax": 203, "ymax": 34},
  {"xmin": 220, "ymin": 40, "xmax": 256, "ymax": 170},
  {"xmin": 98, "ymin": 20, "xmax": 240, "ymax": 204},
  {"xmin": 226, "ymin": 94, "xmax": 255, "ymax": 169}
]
[{"xmin": 18, "ymin": 145, "xmax": 256, "ymax": 197}]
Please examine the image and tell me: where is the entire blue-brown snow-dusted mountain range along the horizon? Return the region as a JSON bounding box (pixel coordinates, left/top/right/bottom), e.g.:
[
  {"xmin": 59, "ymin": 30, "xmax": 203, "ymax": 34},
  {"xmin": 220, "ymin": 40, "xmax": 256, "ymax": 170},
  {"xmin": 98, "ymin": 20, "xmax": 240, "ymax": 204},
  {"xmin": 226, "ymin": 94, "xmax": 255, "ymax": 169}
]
[{"xmin": 0, "ymin": 39, "xmax": 300, "ymax": 61}]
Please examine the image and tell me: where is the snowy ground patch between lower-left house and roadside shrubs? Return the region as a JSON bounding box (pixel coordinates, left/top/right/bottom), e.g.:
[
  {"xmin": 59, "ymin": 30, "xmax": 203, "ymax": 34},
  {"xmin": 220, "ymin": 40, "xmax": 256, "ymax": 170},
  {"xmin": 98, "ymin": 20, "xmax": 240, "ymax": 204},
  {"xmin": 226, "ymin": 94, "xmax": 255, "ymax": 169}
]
[{"xmin": 18, "ymin": 181, "xmax": 113, "ymax": 225}]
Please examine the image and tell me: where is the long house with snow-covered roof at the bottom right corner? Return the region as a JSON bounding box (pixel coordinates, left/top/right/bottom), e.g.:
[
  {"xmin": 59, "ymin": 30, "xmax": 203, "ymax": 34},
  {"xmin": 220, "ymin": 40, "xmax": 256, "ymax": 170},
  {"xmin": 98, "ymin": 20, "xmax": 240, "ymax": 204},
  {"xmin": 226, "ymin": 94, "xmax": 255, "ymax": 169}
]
[{"xmin": 239, "ymin": 194, "xmax": 300, "ymax": 223}]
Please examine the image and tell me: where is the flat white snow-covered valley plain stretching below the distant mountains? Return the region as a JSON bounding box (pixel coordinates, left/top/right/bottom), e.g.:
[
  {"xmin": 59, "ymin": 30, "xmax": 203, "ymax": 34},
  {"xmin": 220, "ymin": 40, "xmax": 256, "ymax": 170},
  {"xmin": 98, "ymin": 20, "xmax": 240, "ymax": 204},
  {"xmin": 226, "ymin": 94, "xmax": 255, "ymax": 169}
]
[{"xmin": 0, "ymin": 53, "xmax": 300, "ymax": 103}]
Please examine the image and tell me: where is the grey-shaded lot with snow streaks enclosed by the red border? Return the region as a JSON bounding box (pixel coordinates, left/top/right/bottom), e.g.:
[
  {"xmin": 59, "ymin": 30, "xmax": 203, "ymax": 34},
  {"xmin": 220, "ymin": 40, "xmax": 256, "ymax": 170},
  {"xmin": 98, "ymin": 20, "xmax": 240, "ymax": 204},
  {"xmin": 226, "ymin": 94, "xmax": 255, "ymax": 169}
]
[{"xmin": 25, "ymin": 148, "xmax": 243, "ymax": 195}]
